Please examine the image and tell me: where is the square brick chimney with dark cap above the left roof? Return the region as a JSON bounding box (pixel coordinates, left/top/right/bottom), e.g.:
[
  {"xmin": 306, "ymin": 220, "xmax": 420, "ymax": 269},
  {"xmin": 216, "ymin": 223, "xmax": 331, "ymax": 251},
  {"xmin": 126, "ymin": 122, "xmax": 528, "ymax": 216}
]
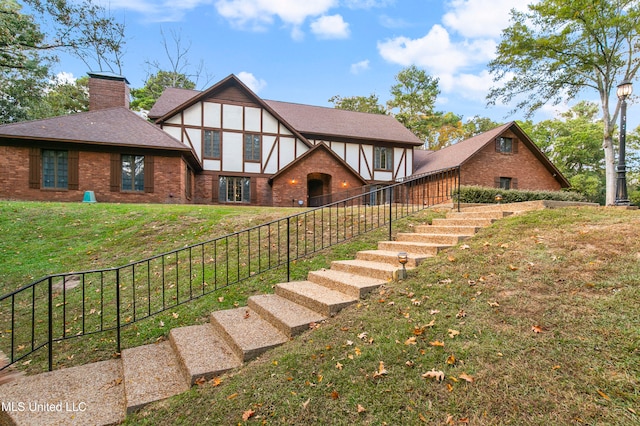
[{"xmin": 89, "ymin": 72, "xmax": 129, "ymax": 111}]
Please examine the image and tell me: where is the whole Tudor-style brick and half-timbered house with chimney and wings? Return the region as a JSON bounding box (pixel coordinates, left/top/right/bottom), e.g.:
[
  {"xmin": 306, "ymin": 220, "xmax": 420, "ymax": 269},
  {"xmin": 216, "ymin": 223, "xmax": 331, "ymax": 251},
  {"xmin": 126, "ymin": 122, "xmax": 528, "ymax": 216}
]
[{"xmin": 0, "ymin": 73, "xmax": 568, "ymax": 206}]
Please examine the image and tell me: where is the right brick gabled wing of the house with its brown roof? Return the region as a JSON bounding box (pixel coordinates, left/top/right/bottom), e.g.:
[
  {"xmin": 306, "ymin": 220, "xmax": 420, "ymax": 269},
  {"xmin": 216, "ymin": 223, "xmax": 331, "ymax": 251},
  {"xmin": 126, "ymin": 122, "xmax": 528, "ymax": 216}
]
[{"xmin": 414, "ymin": 122, "xmax": 571, "ymax": 191}]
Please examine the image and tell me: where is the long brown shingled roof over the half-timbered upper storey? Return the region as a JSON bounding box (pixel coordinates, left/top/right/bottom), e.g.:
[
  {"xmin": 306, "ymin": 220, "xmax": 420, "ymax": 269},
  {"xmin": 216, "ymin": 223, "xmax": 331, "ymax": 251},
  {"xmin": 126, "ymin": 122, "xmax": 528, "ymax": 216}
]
[{"xmin": 265, "ymin": 100, "xmax": 422, "ymax": 146}]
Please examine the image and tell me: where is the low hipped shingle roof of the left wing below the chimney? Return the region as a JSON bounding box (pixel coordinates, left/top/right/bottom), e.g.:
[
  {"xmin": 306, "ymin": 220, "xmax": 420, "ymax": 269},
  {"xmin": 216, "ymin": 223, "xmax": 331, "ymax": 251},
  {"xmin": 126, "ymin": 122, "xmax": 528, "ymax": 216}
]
[{"xmin": 0, "ymin": 107, "xmax": 191, "ymax": 152}]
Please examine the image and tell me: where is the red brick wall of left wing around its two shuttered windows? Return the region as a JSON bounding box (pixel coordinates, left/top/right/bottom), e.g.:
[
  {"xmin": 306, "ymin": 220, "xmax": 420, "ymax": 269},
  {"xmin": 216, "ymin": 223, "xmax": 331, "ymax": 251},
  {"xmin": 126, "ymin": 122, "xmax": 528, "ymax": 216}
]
[{"xmin": 0, "ymin": 146, "xmax": 187, "ymax": 203}]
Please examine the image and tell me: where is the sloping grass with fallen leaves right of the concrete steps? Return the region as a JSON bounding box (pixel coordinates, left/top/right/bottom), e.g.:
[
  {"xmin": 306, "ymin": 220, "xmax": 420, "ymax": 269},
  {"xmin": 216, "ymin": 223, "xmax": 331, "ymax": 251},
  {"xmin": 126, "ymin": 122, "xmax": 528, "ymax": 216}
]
[{"xmin": 121, "ymin": 208, "xmax": 640, "ymax": 425}]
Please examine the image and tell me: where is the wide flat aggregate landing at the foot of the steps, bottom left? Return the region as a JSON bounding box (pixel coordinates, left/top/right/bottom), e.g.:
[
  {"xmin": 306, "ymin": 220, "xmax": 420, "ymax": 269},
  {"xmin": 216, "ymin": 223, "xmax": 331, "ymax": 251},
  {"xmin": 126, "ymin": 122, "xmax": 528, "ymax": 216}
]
[{"xmin": 0, "ymin": 359, "xmax": 125, "ymax": 426}]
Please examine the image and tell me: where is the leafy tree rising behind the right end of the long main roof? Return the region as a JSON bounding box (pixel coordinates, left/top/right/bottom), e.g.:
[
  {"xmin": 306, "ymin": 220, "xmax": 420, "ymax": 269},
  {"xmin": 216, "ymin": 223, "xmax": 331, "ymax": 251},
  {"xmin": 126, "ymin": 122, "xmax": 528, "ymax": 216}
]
[{"xmin": 387, "ymin": 65, "xmax": 440, "ymax": 145}]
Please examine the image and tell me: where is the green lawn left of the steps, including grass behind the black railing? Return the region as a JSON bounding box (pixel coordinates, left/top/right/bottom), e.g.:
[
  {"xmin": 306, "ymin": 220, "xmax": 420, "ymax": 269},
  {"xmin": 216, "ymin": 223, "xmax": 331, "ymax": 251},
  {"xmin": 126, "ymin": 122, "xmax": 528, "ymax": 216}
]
[{"xmin": 0, "ymin": 202, "xmax": 440, "ymax": 373}]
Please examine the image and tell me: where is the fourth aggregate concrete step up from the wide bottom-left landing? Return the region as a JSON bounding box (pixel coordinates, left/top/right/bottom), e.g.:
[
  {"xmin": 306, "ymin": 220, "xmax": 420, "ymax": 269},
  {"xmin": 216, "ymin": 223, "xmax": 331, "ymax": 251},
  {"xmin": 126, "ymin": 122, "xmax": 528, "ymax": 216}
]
[{"xmin": 249, "ymin": 294, "xmax": 326, "ymax": 332}]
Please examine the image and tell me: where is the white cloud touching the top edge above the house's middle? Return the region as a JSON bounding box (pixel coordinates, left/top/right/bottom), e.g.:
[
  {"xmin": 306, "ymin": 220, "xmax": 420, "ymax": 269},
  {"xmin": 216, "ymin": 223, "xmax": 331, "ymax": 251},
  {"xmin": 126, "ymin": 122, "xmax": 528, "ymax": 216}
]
[{"xmin": 215, "ymin": 0, "xmax": 338, "ymax": 30}]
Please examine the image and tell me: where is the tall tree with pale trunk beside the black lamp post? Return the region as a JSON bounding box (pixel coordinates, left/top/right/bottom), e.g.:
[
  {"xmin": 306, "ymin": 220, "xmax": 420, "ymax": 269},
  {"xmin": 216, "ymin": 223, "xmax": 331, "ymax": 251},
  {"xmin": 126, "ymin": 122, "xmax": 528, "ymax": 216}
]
[{"xmin": 488, "ymin": 0, "xmax": 640, "ymax": 204}]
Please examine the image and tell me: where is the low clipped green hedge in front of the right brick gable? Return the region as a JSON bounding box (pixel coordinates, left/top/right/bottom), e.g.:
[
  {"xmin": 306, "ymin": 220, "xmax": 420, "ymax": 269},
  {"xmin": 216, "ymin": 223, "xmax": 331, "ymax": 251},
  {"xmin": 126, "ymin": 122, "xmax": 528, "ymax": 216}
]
[{"xmin": 453, "ymin": 186, "xmax": 586, "ymax": 204}]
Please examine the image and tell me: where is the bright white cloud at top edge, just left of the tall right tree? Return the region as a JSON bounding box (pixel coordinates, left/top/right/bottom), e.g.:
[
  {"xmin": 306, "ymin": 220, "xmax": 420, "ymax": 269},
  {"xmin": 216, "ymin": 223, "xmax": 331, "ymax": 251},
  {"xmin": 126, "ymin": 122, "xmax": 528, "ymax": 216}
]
[{"xmin": 442, "ymin": 0, "xmax": 531, "ymax": 38}]
